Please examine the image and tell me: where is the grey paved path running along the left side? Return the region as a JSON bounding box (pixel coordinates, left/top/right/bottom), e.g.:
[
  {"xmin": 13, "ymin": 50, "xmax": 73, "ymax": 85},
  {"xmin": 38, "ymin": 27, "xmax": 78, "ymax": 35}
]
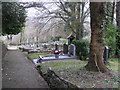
[{"xmin": 2, "ymin": 50, "xmax": 48, "ymax": 88}]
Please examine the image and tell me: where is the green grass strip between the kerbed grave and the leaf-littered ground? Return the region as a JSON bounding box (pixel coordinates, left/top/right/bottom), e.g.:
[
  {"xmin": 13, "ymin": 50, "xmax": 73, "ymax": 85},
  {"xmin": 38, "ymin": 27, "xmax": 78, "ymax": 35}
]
[{"xmin": 41, "ymin": 60, "xmax": 87, "ymax": 72}]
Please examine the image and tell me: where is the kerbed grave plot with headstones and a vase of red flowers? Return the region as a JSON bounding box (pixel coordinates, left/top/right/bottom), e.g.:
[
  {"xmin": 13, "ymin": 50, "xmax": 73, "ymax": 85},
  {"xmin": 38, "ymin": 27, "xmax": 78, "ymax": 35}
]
[{"xmin": 33, "ymin": 44, "xmax": 78, "ymax": 65}]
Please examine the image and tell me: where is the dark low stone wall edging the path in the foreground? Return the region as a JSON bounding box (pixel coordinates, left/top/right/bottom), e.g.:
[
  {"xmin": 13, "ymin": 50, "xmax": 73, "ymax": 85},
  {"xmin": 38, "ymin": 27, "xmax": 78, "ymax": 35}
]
[{"xmin": 37, "ymin": 67, "xmax": 78, "ymax": 89}]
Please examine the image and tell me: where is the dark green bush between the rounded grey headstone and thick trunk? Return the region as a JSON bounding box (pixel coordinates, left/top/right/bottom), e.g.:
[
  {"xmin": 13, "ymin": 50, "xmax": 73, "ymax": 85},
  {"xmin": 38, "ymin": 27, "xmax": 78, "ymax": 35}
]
[{"xmin": 72, "ymin": 39, "xmax": 89, "ymax": 60}]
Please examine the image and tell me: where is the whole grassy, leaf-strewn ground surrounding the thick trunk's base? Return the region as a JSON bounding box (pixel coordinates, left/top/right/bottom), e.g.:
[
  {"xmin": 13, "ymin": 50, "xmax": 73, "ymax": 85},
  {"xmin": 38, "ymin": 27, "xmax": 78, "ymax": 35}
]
[{"xmin": 41, "ymin": 59, "xmax": 120, "ymax": 88}]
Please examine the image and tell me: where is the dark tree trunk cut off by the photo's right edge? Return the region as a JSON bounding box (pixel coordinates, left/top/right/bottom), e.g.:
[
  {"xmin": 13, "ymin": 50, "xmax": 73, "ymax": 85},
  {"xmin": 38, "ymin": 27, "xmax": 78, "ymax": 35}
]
[{"xmin": 115, "ymin": 1, "xmax": 120, "ymax": 57}]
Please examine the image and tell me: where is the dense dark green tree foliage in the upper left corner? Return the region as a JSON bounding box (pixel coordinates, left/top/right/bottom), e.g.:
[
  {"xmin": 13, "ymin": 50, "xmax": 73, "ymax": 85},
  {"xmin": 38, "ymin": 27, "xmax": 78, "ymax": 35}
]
[{"xmin": 2, "ymin": 2, "xmax": 26, "ymax": 35}]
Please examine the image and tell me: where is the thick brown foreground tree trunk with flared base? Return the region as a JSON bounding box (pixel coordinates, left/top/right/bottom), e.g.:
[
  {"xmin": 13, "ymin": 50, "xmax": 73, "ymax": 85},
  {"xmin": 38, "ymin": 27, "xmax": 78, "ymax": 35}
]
[{"xmin": 85, "ymin": 2, "xmax": 108, "ymax": 72}]
